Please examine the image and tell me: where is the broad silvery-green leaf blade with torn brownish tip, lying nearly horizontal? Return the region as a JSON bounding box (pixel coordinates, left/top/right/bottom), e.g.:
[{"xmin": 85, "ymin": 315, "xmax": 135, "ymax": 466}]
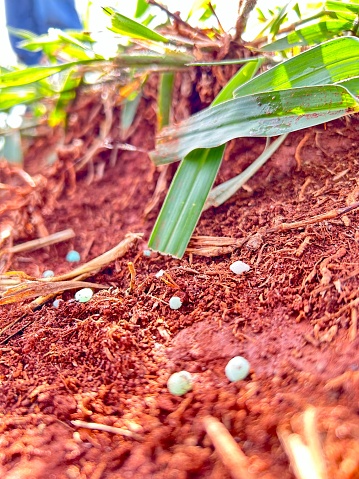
[{"xmin": 151, "ymin": 84, "xmax": 359, "ymax": 164}]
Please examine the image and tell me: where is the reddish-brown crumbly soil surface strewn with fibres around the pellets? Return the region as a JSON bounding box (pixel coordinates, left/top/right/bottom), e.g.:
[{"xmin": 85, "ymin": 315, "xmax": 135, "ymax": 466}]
[{"xmin": 0, "ymin": 96, "xmax": 359, "ymax": 479}]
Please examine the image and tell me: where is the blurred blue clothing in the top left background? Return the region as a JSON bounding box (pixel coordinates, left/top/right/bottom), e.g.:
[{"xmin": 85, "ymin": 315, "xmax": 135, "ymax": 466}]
[{"xmin": 5, "ymin": 0, "xmax": 82, "ymax": 65}]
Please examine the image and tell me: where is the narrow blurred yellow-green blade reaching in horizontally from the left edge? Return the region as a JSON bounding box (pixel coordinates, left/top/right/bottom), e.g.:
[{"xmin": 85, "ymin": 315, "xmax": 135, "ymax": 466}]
[{"xmin": 0, "ymin": 60, "xmax": 96, "ymax": 88}]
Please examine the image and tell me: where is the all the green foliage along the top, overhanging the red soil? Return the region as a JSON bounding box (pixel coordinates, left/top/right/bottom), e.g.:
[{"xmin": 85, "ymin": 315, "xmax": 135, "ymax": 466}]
[{"xmin": 0, "ymin": 0, "xmax": 359, "ymax": 257}]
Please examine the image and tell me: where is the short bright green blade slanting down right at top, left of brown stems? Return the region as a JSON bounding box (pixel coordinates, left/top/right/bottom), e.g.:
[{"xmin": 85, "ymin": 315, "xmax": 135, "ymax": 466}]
[{"xmin": 103, "ymin": 7, "xmax": 169, "ymax": 43}]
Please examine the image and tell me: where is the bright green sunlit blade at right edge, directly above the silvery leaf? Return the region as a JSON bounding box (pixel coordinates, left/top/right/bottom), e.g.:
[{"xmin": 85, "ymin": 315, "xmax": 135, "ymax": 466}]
[{"xmin": 234, "ymin": 37, "xmax": 359, "ymax": 97}]
